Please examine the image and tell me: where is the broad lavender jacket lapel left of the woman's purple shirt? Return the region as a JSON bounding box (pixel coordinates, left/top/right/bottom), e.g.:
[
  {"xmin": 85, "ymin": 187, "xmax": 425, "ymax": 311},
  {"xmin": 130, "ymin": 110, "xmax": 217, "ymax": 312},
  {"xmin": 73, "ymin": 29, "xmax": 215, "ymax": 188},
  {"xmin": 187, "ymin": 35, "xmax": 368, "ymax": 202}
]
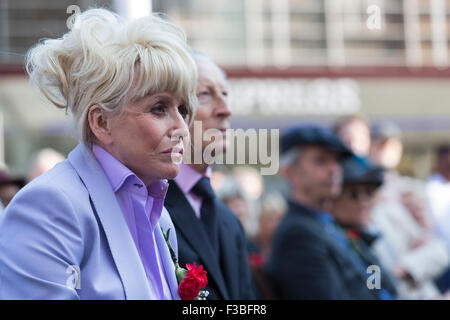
[{"xmin": 68, "ymin": 143, "xmax": 151, "ymax": 300}]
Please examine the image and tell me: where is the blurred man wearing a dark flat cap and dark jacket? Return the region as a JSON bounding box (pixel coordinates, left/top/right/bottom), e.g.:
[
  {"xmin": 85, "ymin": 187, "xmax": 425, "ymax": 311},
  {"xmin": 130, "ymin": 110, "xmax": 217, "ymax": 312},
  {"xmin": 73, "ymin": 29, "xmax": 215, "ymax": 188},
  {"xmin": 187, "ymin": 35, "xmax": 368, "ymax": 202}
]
[{"xmin": 266, "ymin": 126, "xmax": 392, "ymax": 299}]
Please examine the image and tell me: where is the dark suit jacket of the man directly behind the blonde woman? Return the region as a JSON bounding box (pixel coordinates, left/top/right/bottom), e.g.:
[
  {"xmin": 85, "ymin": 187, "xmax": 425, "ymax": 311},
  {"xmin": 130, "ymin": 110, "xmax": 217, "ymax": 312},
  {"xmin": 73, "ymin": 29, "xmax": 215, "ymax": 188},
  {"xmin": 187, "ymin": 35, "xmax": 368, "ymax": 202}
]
[{"xmin": 165, "ymin": 181, "xmax": 254, "ymax": 300}]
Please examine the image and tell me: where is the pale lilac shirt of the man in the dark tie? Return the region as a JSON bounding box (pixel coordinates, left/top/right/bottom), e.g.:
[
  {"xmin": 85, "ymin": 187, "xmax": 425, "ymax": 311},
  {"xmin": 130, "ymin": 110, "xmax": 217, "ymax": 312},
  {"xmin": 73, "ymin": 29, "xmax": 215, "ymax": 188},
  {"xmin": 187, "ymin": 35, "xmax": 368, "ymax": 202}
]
[{"xmin": 174, "ymin": 163, "xmax": 212, "ymax": 219}]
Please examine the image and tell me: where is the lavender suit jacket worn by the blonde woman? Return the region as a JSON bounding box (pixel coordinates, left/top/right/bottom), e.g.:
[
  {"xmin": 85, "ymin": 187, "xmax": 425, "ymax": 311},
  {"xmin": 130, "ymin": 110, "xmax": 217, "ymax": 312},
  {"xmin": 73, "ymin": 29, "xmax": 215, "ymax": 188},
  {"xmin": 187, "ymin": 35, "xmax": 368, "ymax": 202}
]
[{"xmin": 0, "ymin": 143, "xmax": 179, "ymax": 299}]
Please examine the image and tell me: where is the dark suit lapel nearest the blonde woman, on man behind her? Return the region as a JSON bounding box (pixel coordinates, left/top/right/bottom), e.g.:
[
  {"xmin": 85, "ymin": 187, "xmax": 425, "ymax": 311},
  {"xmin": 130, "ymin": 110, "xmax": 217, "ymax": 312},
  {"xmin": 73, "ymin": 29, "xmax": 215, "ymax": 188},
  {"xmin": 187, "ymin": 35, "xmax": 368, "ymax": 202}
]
[{"xmin": 165, "ymin": 181, "xmax": 228, "ymax": 299}]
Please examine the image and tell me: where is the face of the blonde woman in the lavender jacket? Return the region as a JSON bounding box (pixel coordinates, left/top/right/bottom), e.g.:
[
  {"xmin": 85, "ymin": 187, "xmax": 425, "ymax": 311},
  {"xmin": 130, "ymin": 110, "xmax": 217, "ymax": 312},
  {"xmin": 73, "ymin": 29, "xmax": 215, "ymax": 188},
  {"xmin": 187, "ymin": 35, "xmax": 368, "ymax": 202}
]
[{"xmin": 107, "ymin": 92, "xmax": 189, "ymax": 185}]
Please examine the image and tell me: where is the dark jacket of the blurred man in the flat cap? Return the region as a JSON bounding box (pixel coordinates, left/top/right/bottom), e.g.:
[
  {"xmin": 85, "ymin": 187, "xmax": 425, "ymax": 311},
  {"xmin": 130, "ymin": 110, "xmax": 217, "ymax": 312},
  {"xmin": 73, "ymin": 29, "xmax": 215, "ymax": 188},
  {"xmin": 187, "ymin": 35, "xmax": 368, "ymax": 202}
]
[{"xmin": 266, "ymin": 201, "xmax": 386, "ymax": 300}]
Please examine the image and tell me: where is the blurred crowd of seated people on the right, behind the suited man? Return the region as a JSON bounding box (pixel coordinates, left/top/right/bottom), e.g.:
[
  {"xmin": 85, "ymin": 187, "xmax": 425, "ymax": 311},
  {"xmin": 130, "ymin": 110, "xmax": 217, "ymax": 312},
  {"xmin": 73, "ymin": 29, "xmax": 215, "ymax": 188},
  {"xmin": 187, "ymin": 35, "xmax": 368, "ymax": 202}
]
[{"xmin": 212, "ymin": 115, "xmax": 450, "ymax": 299}]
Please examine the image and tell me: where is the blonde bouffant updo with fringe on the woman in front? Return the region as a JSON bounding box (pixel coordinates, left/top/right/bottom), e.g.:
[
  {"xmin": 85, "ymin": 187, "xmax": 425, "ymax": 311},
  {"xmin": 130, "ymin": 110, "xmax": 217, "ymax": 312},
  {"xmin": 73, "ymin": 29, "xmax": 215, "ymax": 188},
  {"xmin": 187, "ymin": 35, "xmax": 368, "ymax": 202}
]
[{"xmin": 26, "ymin": 9, "xmax": 197, "ymax": 145}]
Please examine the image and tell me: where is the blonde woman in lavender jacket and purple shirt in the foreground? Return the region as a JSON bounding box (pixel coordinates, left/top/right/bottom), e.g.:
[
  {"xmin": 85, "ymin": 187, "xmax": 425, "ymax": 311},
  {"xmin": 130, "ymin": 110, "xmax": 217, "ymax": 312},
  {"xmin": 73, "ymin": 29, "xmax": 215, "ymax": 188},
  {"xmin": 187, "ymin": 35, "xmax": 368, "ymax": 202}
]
[{"xmin": 0, "ymin": 9, "xmax": 197, "ymax": 299}]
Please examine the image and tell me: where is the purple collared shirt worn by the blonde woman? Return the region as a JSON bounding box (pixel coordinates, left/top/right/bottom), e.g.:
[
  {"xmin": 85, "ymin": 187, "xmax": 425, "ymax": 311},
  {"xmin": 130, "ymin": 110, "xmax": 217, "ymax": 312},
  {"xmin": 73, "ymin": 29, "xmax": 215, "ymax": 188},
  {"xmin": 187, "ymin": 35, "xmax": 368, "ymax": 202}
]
[{"xmin": 92, "ymin": 144, "xmax": 173, "ymax": 300}]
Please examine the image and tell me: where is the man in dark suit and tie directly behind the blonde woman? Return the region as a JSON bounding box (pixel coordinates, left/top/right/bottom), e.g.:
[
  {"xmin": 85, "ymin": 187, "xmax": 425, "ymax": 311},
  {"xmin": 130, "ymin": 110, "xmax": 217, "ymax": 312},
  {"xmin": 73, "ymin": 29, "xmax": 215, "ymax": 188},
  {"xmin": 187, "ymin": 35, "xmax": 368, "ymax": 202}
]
[{"xmin": 165, "ymin": 53, "xmax": 254, "ymax": 300}]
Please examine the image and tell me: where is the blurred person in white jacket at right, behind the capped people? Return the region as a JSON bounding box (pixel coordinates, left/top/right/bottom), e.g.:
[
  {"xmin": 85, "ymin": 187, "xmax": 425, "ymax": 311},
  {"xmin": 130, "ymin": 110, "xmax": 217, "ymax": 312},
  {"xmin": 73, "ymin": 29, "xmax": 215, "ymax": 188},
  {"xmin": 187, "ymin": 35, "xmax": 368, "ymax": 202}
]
[{"xmin": 371, "ymin": 124, "xmax": 450, "ymax": 299}]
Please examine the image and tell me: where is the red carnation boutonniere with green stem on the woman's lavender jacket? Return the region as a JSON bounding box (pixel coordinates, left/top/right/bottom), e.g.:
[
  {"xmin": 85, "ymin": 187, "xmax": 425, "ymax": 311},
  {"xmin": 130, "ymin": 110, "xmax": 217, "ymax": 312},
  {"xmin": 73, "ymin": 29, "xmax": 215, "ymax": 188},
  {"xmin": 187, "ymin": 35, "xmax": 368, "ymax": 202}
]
[{"xmin": 161, "ymin": 228, "xmax": 209, "ymax": 300}]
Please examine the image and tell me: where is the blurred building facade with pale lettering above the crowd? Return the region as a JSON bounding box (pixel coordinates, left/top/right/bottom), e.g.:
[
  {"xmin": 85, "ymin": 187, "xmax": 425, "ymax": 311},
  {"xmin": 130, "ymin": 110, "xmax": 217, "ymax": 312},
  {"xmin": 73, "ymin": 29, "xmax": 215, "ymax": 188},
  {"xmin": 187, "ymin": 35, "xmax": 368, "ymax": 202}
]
[{"xmin": 0, "ymin": 0, "xmax": 450, "ymax": 177}]
